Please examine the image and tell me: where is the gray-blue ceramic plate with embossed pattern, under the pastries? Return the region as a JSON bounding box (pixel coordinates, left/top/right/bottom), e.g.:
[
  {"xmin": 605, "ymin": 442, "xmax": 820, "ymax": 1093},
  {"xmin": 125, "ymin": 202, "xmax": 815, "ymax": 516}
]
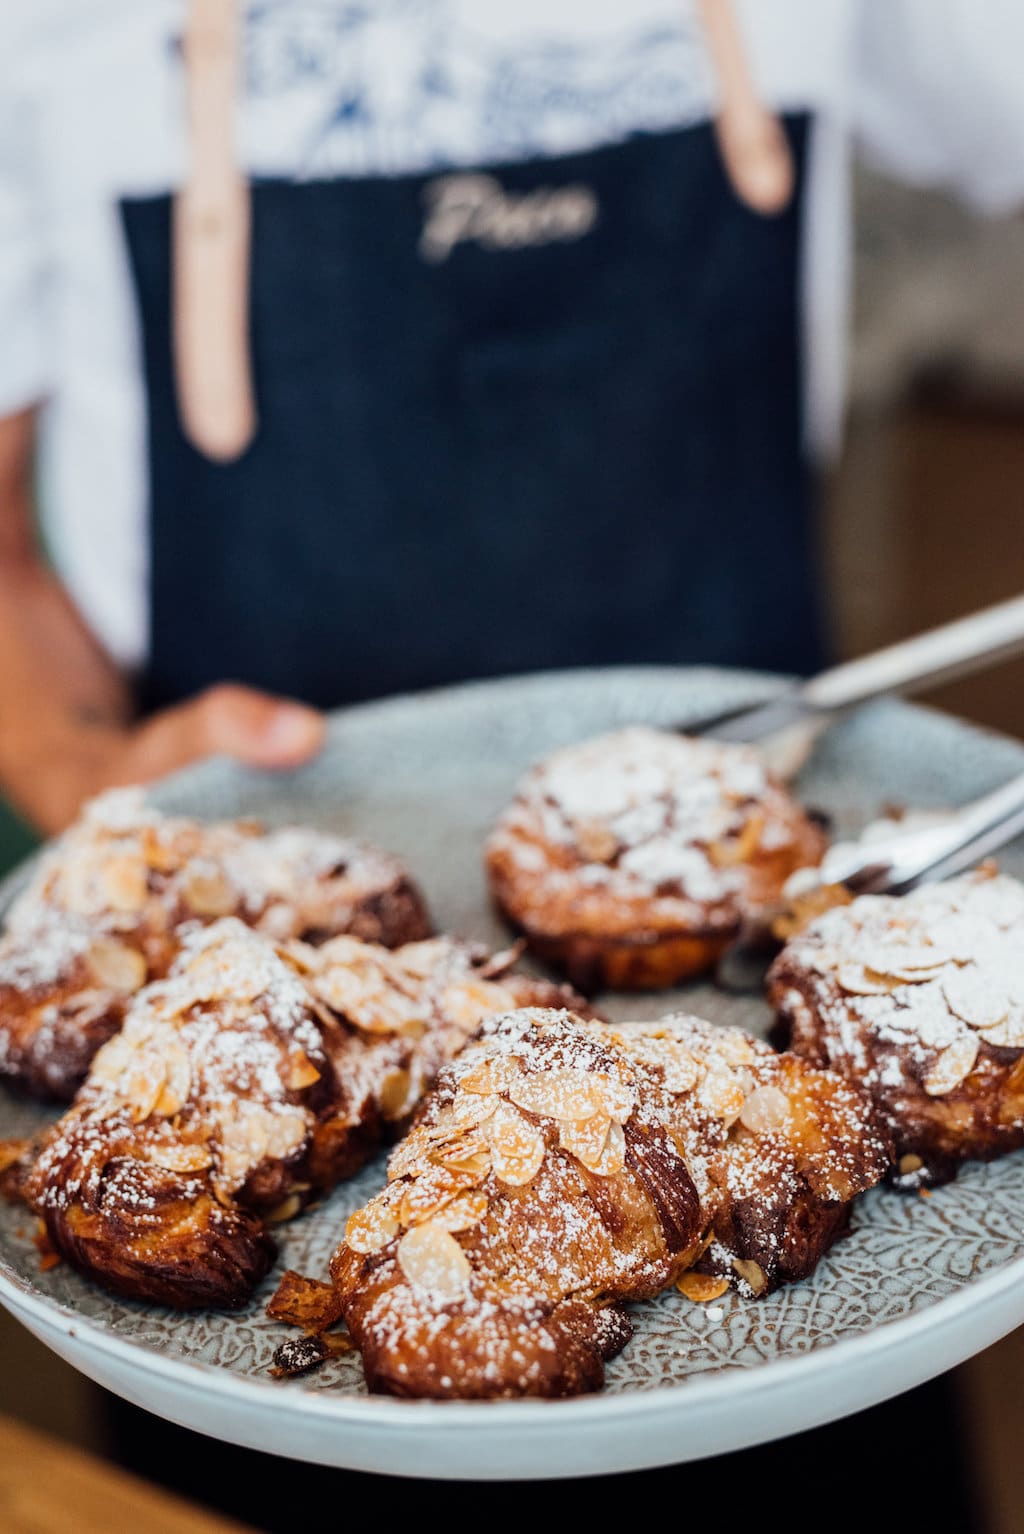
[{"xmin": 0, "ymin": 669, "xmax": 1024, "ymax": 1479}]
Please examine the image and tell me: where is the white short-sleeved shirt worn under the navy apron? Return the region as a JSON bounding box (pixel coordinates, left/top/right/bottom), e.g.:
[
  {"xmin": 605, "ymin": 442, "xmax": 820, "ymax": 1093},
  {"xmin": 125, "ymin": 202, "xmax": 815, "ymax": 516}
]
[{"xmin": 0, "ymin": 0, "xmax": 1024, "ymax": 666}]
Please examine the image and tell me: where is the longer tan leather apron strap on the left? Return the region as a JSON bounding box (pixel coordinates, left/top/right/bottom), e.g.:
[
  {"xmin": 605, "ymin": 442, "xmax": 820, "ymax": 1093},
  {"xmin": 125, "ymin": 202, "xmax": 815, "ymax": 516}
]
[{"xmin": 172, "ymin": 0, "xmax": 256, "ymax": 462}]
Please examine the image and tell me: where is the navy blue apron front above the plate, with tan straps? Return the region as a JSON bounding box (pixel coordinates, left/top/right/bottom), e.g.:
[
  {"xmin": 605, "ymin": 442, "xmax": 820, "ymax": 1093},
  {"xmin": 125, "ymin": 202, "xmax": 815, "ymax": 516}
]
[{"xmin": 124, "ymin": 117, "xmax": 820, "ymax": 706}]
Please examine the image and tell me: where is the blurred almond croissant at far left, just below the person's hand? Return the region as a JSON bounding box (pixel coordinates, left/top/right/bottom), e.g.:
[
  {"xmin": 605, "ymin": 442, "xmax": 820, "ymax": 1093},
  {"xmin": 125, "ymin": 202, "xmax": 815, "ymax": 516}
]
[{"xmin": 0, "ymin": 790, "xmax": 429, "ymax": 1100}]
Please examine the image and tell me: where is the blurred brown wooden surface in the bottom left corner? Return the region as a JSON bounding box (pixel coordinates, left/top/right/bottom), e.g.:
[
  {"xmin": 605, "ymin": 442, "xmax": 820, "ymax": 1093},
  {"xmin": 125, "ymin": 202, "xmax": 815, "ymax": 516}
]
[{"xmin": 0, "ymin": 1417, "xmax": 251, "ymax": 1534}]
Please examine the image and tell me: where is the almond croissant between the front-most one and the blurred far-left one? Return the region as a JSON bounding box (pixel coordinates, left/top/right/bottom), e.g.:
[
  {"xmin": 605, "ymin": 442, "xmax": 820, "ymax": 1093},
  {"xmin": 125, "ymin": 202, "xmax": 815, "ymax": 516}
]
[{"xmin": 23, "ymin": 917, "xmax": 576, "ymax": 1309}]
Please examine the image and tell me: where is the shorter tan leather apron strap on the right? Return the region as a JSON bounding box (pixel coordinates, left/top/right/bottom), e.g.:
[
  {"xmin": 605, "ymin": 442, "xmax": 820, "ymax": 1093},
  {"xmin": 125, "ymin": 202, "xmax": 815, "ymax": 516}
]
[{"xmin": 696, "ymin": 0, "xmax": 796, "ymax": 213}]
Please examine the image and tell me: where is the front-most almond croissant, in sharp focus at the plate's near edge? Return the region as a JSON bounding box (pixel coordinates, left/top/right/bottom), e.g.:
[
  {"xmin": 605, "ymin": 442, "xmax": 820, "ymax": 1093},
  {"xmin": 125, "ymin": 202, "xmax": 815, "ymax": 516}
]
[{"xmin": 306, "ymin": 1009, "xmax": 889, "ymax": 1399}]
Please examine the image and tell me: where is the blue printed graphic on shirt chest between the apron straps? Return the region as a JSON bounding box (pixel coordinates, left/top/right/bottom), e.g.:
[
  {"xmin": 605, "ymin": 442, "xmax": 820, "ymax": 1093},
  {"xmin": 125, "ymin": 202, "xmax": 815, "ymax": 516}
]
[{"xmin": 245, "ymin": 0, "xmax": 713, "ymax": 176}]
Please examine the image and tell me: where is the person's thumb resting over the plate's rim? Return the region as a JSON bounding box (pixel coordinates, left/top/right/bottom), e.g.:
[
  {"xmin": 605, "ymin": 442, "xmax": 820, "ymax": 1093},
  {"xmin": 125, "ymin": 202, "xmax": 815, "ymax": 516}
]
[{"xmin": 133, "ymin": 683, "xmax": 323, "ymax": 776}]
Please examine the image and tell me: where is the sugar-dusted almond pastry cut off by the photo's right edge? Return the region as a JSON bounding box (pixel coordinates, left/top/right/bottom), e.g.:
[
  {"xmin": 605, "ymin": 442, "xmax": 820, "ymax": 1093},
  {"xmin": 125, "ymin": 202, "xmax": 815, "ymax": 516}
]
[{"xmin": 768, "ymin": 871, "xmax": 1024, "ymax": 1187}]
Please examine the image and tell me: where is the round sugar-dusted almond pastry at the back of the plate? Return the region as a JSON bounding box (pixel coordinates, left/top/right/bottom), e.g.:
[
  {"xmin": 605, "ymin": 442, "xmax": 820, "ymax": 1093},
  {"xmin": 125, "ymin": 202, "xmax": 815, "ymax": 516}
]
[{"xmin": 486, "ymin": 727, "xmax": 826, "ymax": 991}]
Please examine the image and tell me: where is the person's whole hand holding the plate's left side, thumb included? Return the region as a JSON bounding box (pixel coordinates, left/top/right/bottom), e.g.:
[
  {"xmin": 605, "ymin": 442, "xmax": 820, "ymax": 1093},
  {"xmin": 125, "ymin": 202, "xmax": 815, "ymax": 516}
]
[{"xmin": 2, "ymin": 684, "xmax": 323, "ymax": 833}]
